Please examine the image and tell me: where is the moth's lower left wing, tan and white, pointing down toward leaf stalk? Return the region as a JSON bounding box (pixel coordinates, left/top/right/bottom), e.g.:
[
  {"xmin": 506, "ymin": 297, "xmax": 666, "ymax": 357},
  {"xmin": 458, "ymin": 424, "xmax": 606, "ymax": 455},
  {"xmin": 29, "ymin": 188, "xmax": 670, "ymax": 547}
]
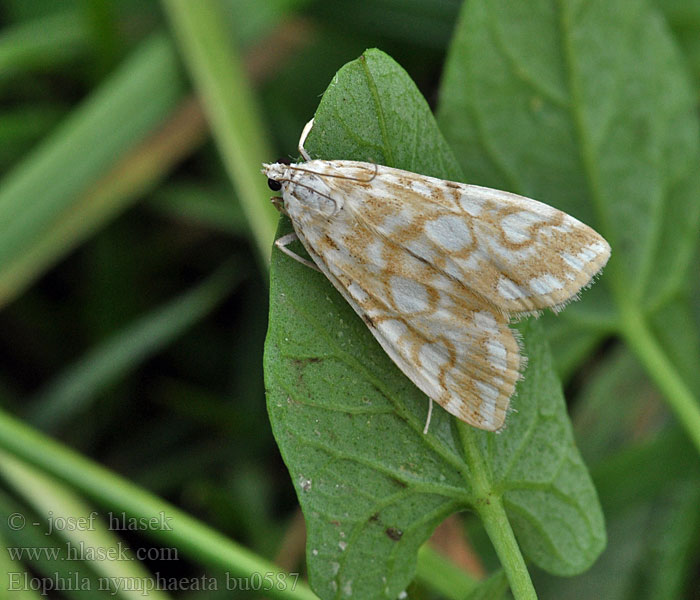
[{"xmin": 290, "ymin": 206, "xmax": 522, "ymax": 431}]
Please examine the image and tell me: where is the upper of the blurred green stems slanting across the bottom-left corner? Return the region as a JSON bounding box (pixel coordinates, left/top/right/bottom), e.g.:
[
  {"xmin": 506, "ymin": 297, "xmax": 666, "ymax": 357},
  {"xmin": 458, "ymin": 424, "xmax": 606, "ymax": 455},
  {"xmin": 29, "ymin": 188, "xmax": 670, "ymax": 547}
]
[{"xmin": 0, "ymin": 411, "xmax": 316, "ymax": 600}]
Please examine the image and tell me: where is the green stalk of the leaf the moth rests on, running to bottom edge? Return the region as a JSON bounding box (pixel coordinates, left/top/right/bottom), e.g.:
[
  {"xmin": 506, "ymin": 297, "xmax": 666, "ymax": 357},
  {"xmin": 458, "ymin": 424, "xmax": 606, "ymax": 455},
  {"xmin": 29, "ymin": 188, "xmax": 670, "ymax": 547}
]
[{"xmin": 458, "ymin": 422, "xmax": 537, "ymax": 600}]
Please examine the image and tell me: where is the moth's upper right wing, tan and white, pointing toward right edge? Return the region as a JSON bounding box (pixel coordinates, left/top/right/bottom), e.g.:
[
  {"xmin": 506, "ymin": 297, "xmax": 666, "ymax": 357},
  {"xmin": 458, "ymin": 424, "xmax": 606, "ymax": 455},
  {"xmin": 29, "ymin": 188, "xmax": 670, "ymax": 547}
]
[{"xmin": 333, "ymin": 161, "xmax": 610, "ymax": 314}]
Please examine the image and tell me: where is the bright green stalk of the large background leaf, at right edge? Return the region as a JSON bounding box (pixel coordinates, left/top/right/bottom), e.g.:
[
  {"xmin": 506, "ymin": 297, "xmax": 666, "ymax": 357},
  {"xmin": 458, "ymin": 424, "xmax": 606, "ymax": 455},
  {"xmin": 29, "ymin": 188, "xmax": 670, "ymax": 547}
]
[{"xmin": 620, "ymin": 302, "xmax": 700, "ymax": 452}]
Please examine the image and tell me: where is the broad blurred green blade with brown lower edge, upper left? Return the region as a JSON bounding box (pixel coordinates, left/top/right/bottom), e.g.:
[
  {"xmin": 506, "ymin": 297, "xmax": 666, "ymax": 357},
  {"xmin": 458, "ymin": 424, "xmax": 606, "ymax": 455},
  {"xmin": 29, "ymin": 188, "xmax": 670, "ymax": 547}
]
[{"xmin": 0, "ymin": 34, "xmax": 191, "ymax": 304}]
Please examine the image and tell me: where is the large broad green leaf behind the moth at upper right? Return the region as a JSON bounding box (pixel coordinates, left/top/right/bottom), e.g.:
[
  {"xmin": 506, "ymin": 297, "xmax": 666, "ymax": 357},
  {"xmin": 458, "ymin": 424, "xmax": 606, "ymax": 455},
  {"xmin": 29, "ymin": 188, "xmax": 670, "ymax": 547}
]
[{"xmin": 439, "ymin": 0, "xmax": 700, "ymax": 306}]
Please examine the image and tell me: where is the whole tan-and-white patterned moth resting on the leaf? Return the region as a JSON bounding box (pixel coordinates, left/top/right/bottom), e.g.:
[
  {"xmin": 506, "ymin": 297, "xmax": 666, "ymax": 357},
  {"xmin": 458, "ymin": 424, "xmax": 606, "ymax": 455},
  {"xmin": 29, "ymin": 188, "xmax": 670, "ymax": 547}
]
[{"xmin": 263, "ymin": 119, "xmax": 610, "ymax": 432}]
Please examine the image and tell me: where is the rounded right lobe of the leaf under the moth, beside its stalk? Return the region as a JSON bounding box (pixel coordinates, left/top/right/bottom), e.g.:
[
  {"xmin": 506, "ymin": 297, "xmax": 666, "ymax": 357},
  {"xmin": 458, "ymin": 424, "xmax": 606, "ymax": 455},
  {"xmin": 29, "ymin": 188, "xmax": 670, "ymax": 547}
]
[{"xmin": 494, "ymin": 320, "xmax": 605, "ymax": 575}]
